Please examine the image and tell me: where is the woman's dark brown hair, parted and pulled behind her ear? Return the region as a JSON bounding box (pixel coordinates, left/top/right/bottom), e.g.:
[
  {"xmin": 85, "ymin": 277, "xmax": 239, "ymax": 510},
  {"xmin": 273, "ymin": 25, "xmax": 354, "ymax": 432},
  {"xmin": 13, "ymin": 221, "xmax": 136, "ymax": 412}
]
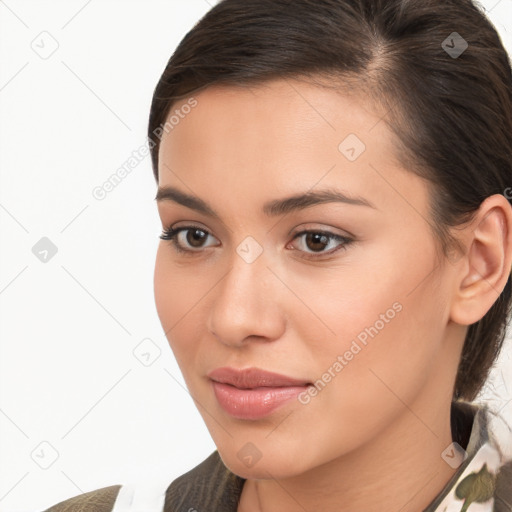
[{"xmin": 148, "ymin": 0, "xmax": 512, "ymax": 401}]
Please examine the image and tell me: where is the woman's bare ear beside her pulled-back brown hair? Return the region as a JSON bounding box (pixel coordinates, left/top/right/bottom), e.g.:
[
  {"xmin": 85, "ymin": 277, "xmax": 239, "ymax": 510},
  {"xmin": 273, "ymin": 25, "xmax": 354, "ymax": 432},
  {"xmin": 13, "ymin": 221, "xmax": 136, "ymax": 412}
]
[{"xmin": 450, "ymin": 194, "xmax": 512, "ymax": 325}]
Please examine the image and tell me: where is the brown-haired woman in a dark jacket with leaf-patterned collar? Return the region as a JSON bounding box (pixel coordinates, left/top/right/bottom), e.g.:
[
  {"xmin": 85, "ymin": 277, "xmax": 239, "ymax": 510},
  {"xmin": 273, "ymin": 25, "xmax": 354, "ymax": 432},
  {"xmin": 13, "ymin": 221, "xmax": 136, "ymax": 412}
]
[{"xmin": 43, "ymin": 0, "xmax": 512, "ymax": 512}]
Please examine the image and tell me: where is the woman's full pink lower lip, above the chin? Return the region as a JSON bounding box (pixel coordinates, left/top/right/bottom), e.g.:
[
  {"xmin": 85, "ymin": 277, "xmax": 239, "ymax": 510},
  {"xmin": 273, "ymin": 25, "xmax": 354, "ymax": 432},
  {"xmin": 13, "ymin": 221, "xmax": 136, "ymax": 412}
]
[{"xmin": 212, "ymin": 381, "xmax": 308, "ymax": 420}]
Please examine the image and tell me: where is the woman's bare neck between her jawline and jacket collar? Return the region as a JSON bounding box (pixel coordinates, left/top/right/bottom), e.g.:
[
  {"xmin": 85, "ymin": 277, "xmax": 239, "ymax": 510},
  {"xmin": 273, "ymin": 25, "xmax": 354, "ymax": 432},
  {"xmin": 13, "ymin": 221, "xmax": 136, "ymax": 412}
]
[{"xmin": 238, "ymin": 397, "xmax": 456, "ymax": 512}]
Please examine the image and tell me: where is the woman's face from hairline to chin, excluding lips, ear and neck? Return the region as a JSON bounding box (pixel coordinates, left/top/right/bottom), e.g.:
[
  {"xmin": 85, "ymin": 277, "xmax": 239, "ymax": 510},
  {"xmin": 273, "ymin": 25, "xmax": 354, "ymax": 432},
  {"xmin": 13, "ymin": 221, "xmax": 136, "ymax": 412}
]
[{"xmin": 154, "ymin": 80, "xmax": 463, "ymax": 478}]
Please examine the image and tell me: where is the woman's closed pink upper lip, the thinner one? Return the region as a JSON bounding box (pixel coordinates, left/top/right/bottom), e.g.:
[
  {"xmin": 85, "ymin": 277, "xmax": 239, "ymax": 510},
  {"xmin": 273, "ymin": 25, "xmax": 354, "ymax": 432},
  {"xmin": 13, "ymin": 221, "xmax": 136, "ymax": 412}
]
[{"xmin": 208, "ymin": 366, "xmax": 311, "ymax": 389}]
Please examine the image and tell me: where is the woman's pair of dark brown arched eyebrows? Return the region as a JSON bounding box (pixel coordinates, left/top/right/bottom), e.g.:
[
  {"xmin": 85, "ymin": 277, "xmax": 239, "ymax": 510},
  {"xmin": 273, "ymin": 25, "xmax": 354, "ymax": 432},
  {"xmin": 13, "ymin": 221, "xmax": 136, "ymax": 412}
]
[{"xmin": 155, "ymin": 186, "xmax": 377, "ymax": 220}]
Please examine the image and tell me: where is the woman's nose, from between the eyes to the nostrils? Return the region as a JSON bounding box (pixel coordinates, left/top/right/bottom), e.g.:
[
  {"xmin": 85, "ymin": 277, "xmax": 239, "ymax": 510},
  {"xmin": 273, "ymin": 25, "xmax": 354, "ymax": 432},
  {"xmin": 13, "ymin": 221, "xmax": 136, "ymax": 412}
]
[{"xmin": 207, "ymin": 247, "xmax": 286, "ymax": 347}]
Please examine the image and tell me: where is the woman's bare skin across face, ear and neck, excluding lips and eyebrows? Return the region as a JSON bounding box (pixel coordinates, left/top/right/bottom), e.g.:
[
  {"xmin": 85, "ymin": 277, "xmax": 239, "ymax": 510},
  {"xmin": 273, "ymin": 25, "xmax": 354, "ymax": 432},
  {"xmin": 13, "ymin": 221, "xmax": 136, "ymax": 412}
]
[{"xmin": 154, "ymin": 80, "xmax": 512, "ymax": 512}]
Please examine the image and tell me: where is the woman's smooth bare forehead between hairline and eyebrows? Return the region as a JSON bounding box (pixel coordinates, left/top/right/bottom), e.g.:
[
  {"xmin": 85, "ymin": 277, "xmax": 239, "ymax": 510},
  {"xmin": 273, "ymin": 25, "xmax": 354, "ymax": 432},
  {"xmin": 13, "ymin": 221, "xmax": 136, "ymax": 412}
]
[{"xmin": 159, "ymin": 79, "xmax": 424, "ymax": 220}]
